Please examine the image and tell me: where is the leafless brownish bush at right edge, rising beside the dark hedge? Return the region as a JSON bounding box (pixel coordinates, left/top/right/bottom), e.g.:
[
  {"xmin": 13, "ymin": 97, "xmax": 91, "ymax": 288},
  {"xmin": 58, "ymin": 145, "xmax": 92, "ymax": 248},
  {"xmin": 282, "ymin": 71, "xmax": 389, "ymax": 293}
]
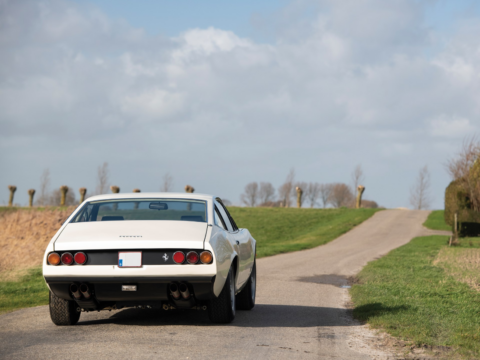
[{"xmin": 447, "ymin": 136, "xmax": 480, "ymax": 212}]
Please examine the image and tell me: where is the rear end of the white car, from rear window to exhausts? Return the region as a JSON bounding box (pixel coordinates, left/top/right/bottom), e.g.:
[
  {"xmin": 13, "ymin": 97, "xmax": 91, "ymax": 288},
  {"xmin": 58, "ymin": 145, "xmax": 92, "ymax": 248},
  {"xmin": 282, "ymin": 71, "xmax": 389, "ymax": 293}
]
[{"xmin": 43, "ymin": 198, "xmax": 216, "ymax": 311}]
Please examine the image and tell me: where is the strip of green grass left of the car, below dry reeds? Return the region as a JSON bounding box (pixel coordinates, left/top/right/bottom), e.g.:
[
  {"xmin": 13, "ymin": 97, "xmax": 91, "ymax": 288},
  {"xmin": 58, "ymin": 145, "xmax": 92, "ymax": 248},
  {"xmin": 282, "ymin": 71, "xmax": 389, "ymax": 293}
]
[{"xmin": 0, "ymin": 267, "xmax": 48, "ymax": 314}]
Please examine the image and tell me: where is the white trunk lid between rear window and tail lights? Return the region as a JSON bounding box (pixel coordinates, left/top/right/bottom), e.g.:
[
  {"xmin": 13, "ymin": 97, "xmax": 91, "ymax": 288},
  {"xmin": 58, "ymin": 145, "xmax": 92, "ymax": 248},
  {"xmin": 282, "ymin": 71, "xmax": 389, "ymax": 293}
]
[{"xmin": 54, "ymin": 220, "xmax": 207, "ymax": 251}]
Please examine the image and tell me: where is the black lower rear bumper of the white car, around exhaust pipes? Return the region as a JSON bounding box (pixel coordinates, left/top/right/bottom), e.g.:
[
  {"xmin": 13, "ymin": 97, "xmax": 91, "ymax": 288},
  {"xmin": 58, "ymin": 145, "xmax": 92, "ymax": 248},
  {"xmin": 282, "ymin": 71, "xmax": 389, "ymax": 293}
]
[{"xmin": 45, "ymin": 276, "xmax": 215, "ymax": 303}]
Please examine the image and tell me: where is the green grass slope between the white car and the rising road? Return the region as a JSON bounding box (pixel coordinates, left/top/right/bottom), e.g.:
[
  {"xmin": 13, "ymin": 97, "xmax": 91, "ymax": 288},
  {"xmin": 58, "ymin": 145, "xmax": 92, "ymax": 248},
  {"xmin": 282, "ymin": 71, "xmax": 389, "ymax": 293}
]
[{"xmin": 229, "ymin": 207, "xmax": 378, "ymax": 257}]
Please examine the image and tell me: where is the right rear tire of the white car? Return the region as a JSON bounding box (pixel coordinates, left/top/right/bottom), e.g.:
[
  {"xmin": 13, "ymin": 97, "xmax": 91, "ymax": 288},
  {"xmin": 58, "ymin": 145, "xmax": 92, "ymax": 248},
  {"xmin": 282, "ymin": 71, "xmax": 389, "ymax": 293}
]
[{"xmin": 207, "ymin": 268, "xmax": 236, "ymax": 324}]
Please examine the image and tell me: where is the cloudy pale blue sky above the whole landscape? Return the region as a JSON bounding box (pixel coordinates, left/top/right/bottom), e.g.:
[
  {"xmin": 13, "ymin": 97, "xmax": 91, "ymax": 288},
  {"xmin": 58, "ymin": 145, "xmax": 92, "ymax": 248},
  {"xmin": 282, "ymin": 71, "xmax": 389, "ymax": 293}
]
[{"xmin": 0, "ymin": 0, "xmax": 480, "ymax": 209}]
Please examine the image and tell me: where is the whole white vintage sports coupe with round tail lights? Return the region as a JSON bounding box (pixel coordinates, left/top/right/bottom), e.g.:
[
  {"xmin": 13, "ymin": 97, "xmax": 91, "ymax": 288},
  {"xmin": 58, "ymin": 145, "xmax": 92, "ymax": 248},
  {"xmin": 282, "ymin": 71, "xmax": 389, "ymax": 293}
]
[{"xmin": 43, "ymin": 193, "xmax": 256, "ymax": 325}]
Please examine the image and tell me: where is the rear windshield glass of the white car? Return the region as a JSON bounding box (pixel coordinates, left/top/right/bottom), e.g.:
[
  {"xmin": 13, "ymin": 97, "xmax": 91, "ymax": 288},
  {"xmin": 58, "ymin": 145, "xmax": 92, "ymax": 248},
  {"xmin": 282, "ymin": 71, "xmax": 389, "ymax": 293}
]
[{"xmin": 71, "ymin": 199, "xmax": 207, "ymax": 223}]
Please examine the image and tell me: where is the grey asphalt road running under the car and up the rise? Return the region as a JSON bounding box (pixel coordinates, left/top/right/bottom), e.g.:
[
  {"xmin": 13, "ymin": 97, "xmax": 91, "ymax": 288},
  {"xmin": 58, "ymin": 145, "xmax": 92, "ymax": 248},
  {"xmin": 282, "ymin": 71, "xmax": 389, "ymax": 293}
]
[{"xmin": 0, "ymin": 210, "xmax": 450, "ymax": 359}]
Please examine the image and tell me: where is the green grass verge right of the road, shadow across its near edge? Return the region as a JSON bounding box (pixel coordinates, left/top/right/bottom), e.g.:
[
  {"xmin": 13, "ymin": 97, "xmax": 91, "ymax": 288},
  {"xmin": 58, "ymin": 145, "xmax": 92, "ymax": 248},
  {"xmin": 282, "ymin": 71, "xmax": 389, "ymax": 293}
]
[{"xmin": 351, "ymin": 236, "xmax": 480, "ymax": 358}]
